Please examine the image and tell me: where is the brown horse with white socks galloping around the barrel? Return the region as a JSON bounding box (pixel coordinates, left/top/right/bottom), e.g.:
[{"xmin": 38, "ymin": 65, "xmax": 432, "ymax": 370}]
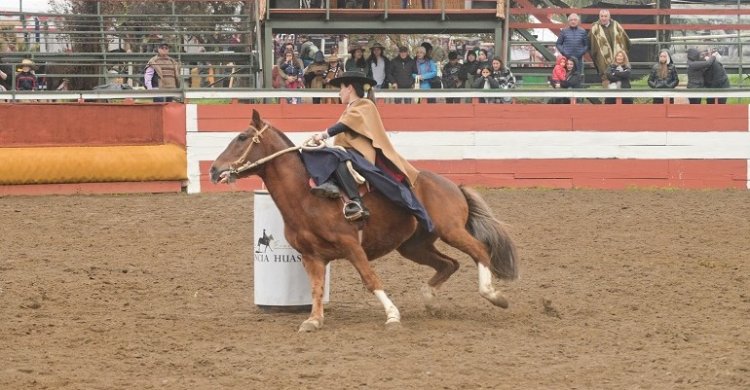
[{"xmin": 210, "ymin": 110, "xmax": 518, "ymax": 332}]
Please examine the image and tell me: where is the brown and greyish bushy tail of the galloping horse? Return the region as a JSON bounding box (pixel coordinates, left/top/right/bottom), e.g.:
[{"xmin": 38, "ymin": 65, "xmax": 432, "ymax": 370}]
[{"xmin": 460, "ymin": 186, "xmax": 518, "ymax": 280}]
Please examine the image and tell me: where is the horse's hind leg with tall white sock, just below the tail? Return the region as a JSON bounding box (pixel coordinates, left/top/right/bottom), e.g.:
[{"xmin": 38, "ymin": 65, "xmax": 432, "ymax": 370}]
[{"xmin": 440, "ymin": 229, "xmax": 508, "ymax": 309}]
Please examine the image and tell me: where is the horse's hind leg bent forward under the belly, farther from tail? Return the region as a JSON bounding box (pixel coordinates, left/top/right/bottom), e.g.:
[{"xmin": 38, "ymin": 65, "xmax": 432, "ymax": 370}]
[{"xmin": 398, "ymin": 233, "xmax": 459, "ymax": 312}]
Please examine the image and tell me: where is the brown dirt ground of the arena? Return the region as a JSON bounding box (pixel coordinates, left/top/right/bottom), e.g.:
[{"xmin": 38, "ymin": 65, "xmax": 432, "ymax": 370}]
[{"xmin": 0, "ymin": 190, "xmax": 750, "ymax": 389}]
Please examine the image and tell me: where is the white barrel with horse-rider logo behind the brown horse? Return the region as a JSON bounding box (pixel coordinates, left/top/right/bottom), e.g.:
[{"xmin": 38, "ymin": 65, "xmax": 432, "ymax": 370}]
[{"xmin": 253, "ymin": 191, "xmax": 331, "ymax": 307}]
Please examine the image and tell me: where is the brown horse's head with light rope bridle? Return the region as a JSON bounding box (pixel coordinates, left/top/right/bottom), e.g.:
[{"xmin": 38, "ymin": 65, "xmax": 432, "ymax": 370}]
[{"xmin": 210, "ymin": 110, "xmax": 280, "ymax": 183}]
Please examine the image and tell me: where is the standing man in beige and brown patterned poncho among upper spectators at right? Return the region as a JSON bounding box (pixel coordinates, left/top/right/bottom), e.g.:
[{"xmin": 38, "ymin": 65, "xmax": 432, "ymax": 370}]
[{"xmin": 592, "ymin": 9, "xmax": 630, "ymax": 88}]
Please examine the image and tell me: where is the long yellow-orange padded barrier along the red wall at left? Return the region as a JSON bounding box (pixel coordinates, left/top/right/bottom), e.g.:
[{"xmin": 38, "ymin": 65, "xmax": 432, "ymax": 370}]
[{"xmin": 0, "ymin": 144, "xmax": 187, "ymax": 184}]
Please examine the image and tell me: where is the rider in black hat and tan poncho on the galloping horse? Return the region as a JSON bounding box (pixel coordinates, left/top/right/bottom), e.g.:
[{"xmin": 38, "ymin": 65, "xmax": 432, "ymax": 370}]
[{"xmin": 302, "ymin": 72, "xmax": 433, "ymax": 231}]
